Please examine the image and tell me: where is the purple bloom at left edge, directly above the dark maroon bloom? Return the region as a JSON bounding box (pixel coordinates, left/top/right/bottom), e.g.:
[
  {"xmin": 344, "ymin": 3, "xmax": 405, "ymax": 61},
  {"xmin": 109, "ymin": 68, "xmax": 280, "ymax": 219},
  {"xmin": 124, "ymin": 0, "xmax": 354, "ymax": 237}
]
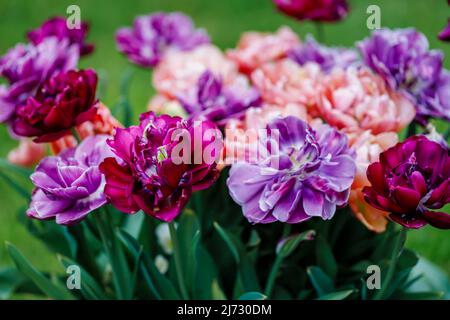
[{"xmin": 0, "ymin": 38, "xmax": 79, "ymax": 122}]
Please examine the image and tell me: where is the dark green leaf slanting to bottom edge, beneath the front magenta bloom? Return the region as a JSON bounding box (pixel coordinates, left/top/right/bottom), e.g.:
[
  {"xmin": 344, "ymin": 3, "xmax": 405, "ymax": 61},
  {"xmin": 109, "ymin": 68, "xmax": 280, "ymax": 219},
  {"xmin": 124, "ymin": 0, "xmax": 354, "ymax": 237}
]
[{"xmin": 119, "ymin": 230, "xmax": 180, "ymax": 300}]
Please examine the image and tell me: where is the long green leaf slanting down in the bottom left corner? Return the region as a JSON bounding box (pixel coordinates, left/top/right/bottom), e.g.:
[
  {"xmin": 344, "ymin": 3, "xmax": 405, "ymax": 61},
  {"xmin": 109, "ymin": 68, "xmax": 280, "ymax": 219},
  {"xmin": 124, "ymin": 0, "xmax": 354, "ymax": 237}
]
[{"xmin": 6, "ymin": 243, "xmax": 74, "ymax": 300}]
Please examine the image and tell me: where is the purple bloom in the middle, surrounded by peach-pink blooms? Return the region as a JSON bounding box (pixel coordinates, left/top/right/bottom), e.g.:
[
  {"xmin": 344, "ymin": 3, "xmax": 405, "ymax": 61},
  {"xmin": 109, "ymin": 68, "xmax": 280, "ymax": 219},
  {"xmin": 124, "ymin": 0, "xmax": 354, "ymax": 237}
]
[{"xmin": 178, "ymin": 71, "xmax": 262, "ymax": 125}]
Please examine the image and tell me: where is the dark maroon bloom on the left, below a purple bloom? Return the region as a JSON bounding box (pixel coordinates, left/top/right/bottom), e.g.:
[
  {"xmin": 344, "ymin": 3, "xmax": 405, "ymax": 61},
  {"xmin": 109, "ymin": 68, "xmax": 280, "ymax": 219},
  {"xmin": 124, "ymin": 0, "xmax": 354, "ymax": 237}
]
[{"xmin": 12, "ymin": 70, "xmax": 97, "ymax": 142}]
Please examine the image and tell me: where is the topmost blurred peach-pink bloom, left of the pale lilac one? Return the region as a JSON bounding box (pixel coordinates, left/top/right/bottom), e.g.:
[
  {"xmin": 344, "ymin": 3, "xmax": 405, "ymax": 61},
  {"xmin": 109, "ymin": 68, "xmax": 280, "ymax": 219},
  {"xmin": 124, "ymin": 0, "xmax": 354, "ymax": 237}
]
[{"xmin": 227, "ymin": 27, "xmax": 300, "ymax": 74}]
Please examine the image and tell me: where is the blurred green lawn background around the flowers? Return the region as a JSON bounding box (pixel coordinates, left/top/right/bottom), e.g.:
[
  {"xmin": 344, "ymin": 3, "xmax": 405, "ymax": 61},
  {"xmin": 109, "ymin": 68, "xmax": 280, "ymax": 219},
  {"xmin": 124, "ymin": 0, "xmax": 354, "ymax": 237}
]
[{"xmin": 0, "ymin": 0, "xmax": 450, "ymax": 275}]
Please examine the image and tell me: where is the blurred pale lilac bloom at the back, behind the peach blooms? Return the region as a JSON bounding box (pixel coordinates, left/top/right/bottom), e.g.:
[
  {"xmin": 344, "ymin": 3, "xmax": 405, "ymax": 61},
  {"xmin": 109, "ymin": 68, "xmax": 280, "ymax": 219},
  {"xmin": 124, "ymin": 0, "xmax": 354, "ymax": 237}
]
[{"xmin": 289, "ymin": 36, "xmax": 359, "ymax": 72}]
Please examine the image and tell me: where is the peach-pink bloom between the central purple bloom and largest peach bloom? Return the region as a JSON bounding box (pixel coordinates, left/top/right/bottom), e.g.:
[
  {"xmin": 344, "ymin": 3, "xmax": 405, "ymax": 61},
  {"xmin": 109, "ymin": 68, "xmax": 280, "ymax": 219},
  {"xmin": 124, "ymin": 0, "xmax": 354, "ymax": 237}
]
[{"xmin": 251, "ymin": 59, "xmax": 323, "ymax": 110}]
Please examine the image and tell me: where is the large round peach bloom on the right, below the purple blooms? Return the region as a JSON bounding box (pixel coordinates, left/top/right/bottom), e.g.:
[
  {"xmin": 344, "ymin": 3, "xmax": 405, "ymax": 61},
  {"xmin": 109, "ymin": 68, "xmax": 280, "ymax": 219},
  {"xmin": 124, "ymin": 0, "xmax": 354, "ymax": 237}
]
[{"xmin": 318, "ymin": 68, "xmax": 415, "ymax": 134}]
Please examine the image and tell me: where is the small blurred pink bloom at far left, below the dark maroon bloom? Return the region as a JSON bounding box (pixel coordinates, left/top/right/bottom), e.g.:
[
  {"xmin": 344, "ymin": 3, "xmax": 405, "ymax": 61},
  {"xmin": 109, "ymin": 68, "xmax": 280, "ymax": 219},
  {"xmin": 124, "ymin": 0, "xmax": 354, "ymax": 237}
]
[{"xmin": 8, "ymin": 138, "xmax": 46, "ymax": 168}]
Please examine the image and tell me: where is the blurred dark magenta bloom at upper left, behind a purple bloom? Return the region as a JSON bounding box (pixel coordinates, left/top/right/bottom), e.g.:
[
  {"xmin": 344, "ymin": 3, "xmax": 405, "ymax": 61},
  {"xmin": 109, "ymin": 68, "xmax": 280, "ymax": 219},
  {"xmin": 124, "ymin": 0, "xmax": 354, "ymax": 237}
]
[{"xmin": 27, "ymin": 17, "xmax": 94, "ymax": 55}]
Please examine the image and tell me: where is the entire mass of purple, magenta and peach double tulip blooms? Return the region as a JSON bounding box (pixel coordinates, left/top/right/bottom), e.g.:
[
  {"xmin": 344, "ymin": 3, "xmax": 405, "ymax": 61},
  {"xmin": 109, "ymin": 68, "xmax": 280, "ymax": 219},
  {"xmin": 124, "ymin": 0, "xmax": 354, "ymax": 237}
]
[{"xmin": 0, "ymin": 10, "xmax": 450, "ymax": 235}]
